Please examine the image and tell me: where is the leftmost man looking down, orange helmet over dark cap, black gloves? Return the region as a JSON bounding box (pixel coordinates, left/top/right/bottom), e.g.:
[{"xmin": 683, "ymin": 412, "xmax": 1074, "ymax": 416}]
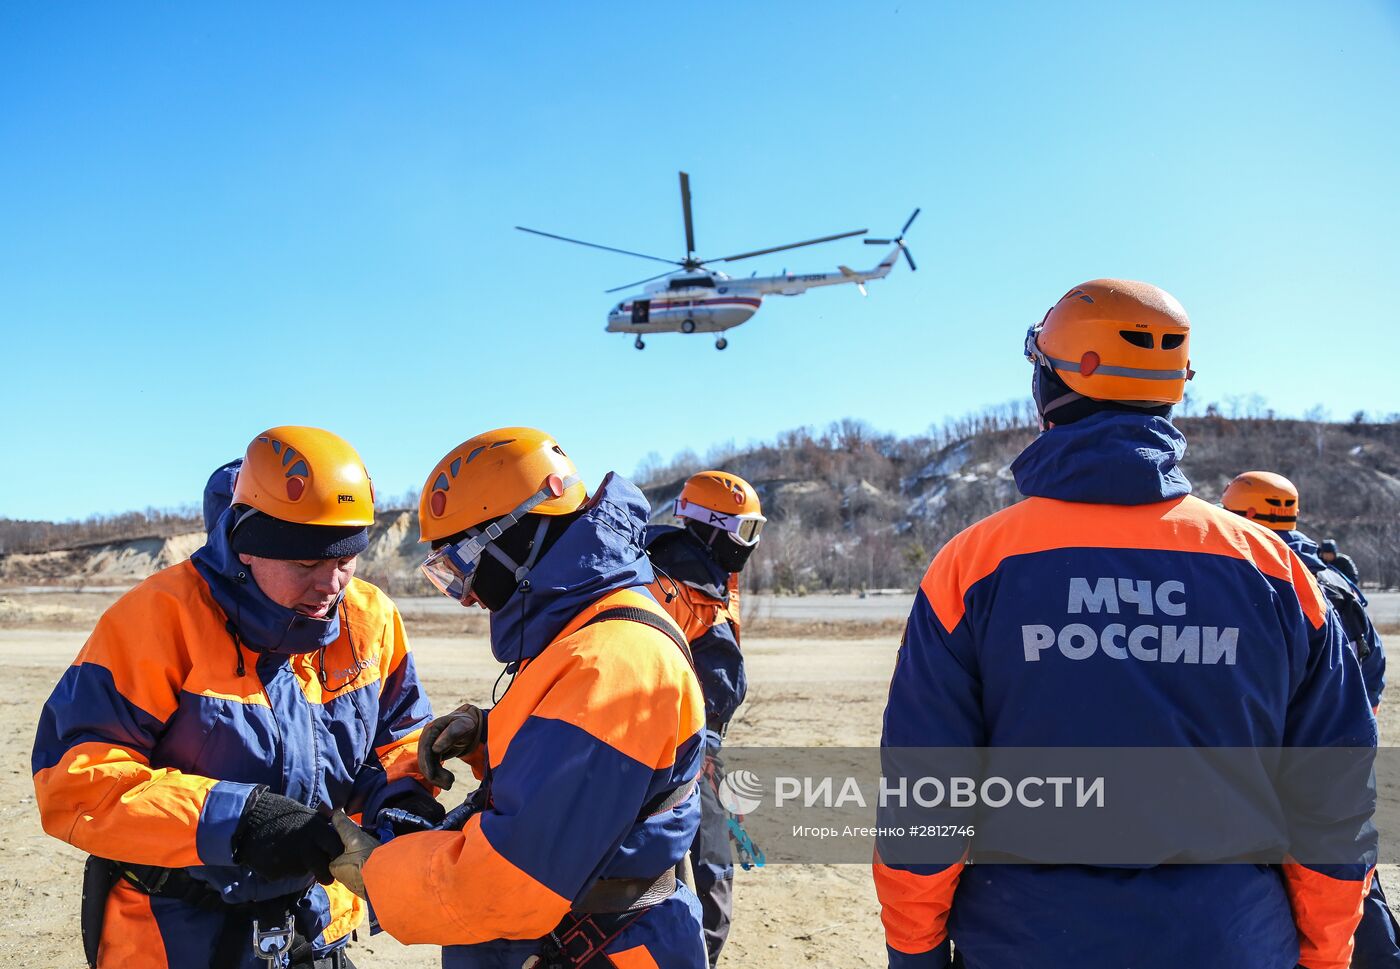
[{"xmin": 34, "ymin": 427, "xmax": 435, "ymax": 969}]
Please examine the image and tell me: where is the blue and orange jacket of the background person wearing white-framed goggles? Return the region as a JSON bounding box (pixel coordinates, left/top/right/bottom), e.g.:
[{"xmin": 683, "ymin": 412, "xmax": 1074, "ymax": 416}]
[{"xmin": 647, "ymin": 525, "xmax": 749, "ymax": 735}]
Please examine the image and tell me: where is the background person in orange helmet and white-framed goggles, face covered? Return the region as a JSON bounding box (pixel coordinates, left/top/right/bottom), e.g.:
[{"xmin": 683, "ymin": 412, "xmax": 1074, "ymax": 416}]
[{"xmin": 647, "ymin": 470, "xmax": 767, "ymax": 966}]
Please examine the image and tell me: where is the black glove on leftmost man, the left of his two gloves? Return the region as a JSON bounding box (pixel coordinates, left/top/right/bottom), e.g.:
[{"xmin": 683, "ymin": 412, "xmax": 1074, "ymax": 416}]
[{"xmin": 234, "ymin": 787, "xmax": 344, "ymax": 885}]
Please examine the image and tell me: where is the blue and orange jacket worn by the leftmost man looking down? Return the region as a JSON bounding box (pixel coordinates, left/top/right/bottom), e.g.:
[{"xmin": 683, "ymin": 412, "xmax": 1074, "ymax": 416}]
[{"xmin": 32, "ymin": 498, "xmax": 431, "ymax": 969}]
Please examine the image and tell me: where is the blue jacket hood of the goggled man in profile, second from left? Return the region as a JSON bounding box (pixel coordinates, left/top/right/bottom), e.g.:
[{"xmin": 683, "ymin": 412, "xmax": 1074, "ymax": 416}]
[{"xmin": 491, "ymin": 473, "xmax": 655, "ymax": 662}]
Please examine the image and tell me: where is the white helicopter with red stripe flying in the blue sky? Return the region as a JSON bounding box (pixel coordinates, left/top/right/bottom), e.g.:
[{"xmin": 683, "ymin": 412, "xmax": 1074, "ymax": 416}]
[{"xmin": 515, "ymin": 172, "xmax": 920, "ymax": 350}]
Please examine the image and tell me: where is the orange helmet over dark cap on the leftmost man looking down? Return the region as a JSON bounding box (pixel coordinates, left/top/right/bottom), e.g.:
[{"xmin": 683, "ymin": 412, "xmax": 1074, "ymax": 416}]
[{"xmin": 232, "ymin": 427, "xmax": 374, "ymax": 528}]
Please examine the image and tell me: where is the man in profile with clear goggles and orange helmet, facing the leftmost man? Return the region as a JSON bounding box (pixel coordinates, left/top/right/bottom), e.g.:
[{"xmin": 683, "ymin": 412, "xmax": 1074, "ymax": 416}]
[{"xmin": 332, "ymin": 427, "xmax": 706, "ymax": 969}]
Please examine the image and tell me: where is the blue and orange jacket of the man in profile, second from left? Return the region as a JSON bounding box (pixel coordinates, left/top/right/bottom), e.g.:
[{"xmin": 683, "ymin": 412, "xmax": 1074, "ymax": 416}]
[{"xmin": 364, "ymin": 476, "xmax": 706, "ymax": 969}]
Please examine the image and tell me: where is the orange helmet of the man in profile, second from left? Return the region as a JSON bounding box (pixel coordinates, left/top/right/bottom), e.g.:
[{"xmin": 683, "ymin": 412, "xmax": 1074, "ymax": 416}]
[{"xmin": 419, "ymin": 427, "xmax": 588, "ymax": 542}]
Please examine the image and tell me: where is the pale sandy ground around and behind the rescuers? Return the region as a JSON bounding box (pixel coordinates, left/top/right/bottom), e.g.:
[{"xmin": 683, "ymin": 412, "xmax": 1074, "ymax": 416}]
[{"xmin": 0, "ymin": 591, "xmax": 1400, "ymax": 969}]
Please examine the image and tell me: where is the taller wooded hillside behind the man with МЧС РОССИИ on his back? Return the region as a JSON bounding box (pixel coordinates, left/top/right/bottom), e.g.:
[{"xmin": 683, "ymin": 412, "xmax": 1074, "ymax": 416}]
[{"xmin": 641, "ymin": 410, "xmax": 1400, "ymax": 591}]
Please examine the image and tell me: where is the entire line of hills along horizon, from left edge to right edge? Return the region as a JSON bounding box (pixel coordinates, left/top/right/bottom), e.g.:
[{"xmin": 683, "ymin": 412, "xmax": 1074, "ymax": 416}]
[{"xmin": 0, "ymin": 407, "xmax": 1400, "ymax": 594}]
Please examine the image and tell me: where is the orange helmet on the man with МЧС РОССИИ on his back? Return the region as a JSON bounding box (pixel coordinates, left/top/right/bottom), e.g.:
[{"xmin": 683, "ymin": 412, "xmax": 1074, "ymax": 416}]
[{"xmin": 1026, "ymin": 279, "xmax": 1193, "ymax": 405}]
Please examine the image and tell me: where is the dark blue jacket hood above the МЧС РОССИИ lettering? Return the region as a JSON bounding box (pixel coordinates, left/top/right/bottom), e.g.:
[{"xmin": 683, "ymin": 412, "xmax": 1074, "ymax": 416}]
[{"xmin": 1011, "ymin": 412, "xmax": 1191, "ymax": 504}]
